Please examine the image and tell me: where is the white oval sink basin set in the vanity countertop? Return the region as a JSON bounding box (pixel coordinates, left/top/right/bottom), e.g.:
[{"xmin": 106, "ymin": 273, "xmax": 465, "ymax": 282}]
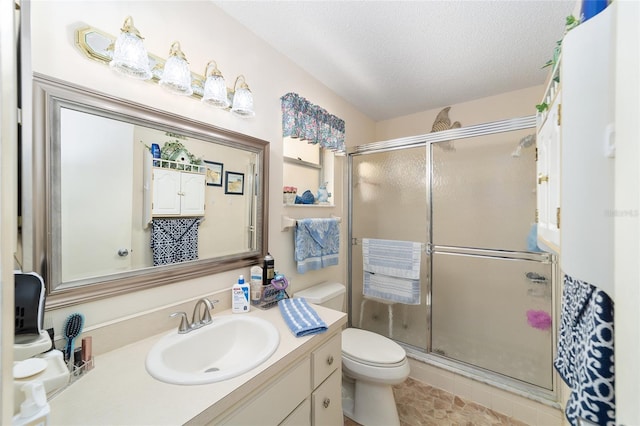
[{"xmin": 146, "ymin": 315, "xmax": 280, "ymax": 385}]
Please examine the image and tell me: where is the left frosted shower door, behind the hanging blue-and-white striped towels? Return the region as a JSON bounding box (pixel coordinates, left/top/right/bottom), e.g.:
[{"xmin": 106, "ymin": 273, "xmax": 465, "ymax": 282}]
[{"xmin": 350, "ymin": 144, "xmax": 429, "ymax": 349}]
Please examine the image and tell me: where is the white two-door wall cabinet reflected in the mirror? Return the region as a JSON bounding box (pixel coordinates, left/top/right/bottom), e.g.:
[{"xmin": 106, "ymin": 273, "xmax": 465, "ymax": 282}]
[{"xmin": 151, "ymin": 167, "xmax": 206, "ymax": 216}]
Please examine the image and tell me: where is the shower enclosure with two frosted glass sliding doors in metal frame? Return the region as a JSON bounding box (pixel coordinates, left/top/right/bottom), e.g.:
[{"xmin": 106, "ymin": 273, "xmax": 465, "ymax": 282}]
[{"xmin": 349, "ymin": 117, "xmax": 555, "ymax": 396}]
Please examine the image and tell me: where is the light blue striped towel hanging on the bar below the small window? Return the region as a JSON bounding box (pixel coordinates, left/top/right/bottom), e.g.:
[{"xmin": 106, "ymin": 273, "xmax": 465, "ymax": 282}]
[{"xmin": 295, "ymin": 218, "xmax": 340, "ymax": 274}]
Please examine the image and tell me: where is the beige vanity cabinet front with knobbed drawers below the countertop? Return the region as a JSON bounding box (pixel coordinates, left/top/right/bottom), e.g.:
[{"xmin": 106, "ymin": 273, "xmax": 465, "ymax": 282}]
[{"xmin": 214, "ymin": 330, "xmax": 343, "ymax": 426}]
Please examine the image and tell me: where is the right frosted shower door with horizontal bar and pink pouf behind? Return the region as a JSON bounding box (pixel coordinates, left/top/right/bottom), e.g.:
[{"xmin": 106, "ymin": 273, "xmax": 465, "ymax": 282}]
[{"xmin": 430, "ymin": 129, "xmax": 553, "ymax": 390}]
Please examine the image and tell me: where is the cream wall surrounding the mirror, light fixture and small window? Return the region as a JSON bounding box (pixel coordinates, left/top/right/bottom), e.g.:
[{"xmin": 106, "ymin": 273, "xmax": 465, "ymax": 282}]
[{"xmin": 32, "ymin": 1, "xmax": 374, "ymax": 333}]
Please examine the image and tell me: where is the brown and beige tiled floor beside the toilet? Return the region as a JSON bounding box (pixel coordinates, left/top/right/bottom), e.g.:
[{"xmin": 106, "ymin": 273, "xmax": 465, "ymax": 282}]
[{"xmin": 344, "ymin": 378, "xmax": 526, "ymax": 426}]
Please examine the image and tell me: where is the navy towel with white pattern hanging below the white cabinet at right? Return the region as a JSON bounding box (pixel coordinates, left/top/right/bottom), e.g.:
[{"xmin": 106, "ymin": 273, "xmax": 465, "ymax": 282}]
[{"xmin": 554, "ymin": 275, "xmax": 616, "ymax": 426}]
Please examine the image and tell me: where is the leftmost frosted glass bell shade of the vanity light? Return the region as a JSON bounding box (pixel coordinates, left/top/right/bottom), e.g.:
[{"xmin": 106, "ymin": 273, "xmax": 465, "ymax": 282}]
[{"xmin": 109, "ymin": 16, "xmax": 152, "ymax": 80}]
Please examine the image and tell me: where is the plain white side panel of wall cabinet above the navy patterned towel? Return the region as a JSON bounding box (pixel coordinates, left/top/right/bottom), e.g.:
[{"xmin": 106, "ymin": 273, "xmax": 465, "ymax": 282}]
[{"xmin": 560, "ymin": 2, "xmax": 616, "ymax": 297}]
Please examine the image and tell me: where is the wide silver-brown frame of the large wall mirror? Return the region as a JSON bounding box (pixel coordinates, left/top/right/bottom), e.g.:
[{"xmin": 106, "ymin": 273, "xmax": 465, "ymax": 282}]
[{"xmin": 21, "ymin": 73, "xmax": 270, "ymax": 309}]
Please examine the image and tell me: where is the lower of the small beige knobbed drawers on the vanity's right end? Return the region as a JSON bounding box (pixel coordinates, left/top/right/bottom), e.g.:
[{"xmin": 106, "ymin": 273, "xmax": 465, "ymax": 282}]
[{"xmin": 311, "ymin": 370, "xmax": 344, "ymax": 426}]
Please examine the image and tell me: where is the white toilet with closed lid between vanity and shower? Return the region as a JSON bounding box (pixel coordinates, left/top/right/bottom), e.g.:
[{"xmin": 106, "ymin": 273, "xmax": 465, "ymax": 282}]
[{"xmin": 294, "ymin": 283, "xmax": 410, "ymax": 426}]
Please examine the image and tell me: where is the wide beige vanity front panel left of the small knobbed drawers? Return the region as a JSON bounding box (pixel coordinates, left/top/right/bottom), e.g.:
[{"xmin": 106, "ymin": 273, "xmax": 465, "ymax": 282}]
[{"xmin": 219, "ymin": 358, "xmax": 311, "ymax": 426}]
